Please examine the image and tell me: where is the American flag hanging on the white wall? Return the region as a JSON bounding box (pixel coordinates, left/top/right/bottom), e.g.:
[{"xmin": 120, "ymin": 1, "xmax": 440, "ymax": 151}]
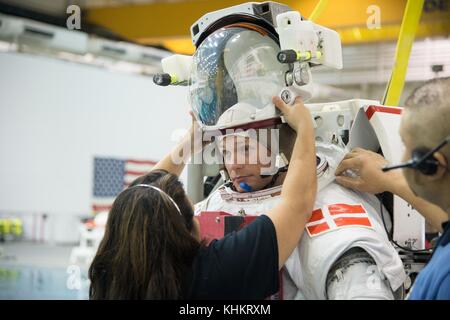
[{"xmin": 92, "ymin": 157, "xmax": 156, "ymax": 212}]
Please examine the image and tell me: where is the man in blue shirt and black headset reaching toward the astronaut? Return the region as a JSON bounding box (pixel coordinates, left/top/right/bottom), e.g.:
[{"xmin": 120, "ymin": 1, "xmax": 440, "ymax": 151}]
[{"xmin": 336, "ymin": 77, "xmax": 450, "ymax": 300}]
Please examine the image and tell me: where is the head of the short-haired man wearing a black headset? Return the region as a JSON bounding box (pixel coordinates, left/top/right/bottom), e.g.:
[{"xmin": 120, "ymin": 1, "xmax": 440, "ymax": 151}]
[{"xmin": 400, "ymin": 77, "xmax": 450, "ymax": 213}]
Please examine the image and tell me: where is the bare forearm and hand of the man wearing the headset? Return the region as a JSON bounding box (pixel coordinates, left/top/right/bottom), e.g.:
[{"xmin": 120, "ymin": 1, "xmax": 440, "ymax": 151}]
[{"xmin": 336, "ymin": 148, "xmax": 448, "ymax": 232}]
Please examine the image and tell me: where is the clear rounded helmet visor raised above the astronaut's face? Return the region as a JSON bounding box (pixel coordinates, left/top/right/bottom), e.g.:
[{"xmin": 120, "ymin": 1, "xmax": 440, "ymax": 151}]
[{"xmin": 189, "ymin": 27, "xmax": 288, "ymax": 128}]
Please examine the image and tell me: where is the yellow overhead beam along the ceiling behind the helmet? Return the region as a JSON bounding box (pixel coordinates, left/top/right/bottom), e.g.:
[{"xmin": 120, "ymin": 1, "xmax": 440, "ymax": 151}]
[{"xmin": 87, "ymin": 0, "xmax": 450, "ymax": 54}]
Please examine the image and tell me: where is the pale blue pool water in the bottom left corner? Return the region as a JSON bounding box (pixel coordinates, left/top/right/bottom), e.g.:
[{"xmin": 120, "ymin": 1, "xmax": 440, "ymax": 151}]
[{"xmin": 0, "ymin": 265, "xmax": 89, "ymax": 300}]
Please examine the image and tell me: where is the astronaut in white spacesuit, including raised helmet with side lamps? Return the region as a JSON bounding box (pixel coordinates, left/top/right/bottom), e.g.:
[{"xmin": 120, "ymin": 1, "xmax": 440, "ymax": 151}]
[{"xmin": 155, "ymin": 2, "xmax": 406, "ymax": 299}]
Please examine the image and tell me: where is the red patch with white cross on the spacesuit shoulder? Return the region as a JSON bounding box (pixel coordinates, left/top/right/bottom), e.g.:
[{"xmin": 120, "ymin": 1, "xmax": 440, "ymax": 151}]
[{"xmin": 305, "ymin": 203, "xmax": 373, "ymax": 237}]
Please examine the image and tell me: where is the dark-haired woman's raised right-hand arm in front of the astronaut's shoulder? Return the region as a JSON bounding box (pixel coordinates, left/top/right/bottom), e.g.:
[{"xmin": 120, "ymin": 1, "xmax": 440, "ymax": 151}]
[{"xmin": 267, "ymin": 97, "xmax": 317, "ymax": 268}]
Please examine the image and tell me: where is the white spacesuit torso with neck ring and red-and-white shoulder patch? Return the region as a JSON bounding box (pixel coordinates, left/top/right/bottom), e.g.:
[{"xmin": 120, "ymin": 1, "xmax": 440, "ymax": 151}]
[{"xmin": 196, "ymin": 147, "xmax": 406, "ymax": 299}]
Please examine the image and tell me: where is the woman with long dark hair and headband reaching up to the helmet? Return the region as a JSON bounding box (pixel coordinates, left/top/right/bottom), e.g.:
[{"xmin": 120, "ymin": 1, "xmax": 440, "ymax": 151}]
[{"xmin": 89, "ymin": 98, "xmax": 317, "ymax": 299}]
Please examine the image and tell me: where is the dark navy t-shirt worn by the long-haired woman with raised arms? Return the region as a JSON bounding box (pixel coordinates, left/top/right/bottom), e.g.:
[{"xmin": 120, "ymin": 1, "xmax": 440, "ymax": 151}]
[{"xmin": 186, "ymin": 215, "xmax": 279, "ymax": 300}]
